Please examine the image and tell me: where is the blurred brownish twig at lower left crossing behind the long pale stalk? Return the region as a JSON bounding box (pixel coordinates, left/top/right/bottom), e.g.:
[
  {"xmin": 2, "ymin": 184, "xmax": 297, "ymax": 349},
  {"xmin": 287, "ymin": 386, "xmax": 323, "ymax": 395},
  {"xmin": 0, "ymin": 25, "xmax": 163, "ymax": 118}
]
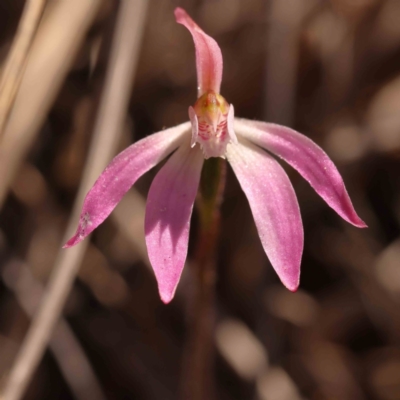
[{"xmin": 3, "ymin": 260, "xmax": 106, "ymax": 400}]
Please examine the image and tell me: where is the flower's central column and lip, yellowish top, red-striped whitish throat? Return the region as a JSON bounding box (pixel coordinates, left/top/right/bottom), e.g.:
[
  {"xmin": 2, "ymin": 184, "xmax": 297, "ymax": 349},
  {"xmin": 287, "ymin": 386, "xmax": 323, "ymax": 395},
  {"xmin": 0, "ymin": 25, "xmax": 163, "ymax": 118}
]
[{"xmin": 189, "ymin": 91, "xmax": 237, "ymax": 159}]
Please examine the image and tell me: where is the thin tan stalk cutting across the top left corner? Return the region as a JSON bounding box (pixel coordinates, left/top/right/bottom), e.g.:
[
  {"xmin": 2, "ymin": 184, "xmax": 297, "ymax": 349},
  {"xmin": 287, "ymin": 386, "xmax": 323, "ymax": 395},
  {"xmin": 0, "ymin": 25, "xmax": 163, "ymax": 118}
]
[{"xmin": 0, "ymin": 0, "xmax": 47, "ymax": 137}]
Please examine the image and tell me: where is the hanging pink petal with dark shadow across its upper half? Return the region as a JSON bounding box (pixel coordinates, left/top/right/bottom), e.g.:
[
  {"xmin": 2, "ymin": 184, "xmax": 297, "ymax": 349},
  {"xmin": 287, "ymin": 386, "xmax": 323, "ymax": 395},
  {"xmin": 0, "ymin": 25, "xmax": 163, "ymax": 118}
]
[{"xmin": 145, "ymin": 143, "xmax": 204, "ymax": 303}]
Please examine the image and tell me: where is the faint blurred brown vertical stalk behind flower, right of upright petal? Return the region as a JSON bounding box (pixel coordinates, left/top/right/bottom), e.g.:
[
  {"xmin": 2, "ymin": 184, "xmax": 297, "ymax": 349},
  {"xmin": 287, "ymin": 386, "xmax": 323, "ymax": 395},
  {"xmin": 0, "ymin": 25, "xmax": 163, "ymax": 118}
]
[{"xmin": 265, "ymin": 0, "xmax": 309, "ymax": 126}]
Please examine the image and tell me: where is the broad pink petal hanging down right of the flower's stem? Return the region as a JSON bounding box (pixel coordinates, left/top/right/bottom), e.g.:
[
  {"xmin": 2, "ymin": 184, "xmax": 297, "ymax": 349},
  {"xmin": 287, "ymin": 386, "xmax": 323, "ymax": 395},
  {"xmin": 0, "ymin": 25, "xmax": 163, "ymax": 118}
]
[{"xmin": 227, "ymin": 141, "xmax": 303, "ymax": 291}]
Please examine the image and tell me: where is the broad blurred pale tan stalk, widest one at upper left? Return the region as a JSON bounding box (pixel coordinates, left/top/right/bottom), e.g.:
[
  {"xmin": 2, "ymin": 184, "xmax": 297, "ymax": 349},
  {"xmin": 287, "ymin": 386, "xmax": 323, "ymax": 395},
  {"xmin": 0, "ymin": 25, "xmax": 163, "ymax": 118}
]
[{"xmin": 0, "ymin": 0, "xmax": 102, "ymax": 211}]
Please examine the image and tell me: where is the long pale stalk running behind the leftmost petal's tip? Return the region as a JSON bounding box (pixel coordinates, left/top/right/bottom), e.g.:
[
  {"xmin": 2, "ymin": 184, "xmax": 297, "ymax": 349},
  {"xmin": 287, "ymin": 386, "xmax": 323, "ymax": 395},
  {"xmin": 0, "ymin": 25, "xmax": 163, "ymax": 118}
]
[{"xmin": 2, "ymin": 0, "xmax": 148, "ymax": 400}]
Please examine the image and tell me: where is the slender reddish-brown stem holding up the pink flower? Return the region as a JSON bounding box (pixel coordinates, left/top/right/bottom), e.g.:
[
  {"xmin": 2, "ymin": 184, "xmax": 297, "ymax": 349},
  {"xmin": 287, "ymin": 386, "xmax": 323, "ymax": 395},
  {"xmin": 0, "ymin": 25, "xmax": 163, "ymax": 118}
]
[{"xmin": 182, "ymin": 158, "xmax": 226, "ymax": 400}]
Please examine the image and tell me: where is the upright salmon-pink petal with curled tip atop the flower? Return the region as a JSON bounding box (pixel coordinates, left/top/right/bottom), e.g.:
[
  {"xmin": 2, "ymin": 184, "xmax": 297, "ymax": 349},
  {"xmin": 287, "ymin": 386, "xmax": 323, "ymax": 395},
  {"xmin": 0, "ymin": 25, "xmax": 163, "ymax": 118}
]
[{"xmin": 175, "ymin": 7, "xmax": 222, "ymax": 97}]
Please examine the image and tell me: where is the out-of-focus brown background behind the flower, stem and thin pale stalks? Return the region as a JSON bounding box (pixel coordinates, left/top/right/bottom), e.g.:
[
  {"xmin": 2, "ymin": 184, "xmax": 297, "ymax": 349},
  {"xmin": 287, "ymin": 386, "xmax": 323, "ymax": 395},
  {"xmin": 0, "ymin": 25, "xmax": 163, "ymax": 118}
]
[{"xmin": 0, "ymin": 0, "xmax": 400, "ymax": 400}]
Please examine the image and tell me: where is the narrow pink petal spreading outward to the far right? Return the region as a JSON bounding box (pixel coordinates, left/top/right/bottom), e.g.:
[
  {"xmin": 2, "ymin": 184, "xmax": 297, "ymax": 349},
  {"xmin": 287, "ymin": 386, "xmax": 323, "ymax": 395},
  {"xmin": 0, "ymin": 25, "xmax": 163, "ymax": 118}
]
[{"xmin": 235, "ymin": 118, "xmax": 367, "ymax": 228}]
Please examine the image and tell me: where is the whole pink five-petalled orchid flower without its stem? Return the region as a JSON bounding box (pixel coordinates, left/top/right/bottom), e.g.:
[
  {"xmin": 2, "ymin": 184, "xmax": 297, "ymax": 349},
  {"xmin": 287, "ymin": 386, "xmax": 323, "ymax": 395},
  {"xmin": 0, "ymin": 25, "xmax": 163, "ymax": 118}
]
[{"xmin": 65, "ymin": 8, "xmax": 366, "ymax": 303}]
